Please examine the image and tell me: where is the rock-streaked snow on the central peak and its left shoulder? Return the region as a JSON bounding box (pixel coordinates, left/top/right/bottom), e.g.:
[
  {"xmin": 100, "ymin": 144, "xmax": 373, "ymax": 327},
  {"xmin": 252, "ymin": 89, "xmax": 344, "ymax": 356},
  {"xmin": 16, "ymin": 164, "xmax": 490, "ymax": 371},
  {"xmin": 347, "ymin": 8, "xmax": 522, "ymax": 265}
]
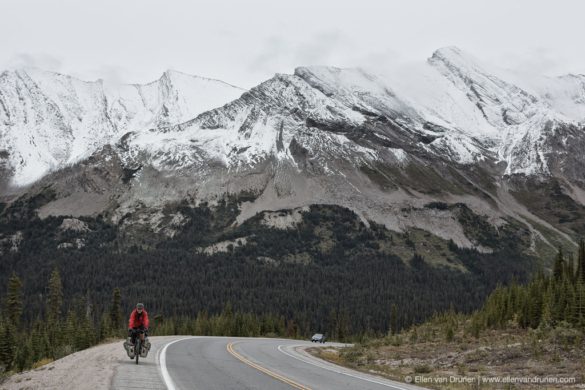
[{"xmin": 123, "ymin": 75, "xmax": 372, "ymax": 175}]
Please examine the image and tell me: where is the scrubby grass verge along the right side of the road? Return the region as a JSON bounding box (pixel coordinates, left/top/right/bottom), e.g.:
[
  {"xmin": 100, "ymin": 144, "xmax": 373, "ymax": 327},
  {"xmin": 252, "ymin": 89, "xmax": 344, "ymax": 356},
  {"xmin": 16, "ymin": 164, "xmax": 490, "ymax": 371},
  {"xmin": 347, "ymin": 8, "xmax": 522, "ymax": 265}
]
[{"xmin": 308, "ymin": 315, "xmax": 585, "ymax": 390}]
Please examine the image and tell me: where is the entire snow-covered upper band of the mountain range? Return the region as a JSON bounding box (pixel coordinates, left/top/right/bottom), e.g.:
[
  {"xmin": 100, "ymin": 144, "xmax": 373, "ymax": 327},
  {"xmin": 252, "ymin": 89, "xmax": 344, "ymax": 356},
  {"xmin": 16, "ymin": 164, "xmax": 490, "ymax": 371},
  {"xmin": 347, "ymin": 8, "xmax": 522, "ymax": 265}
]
[{"xmin": 0, "ymin": 47, "xmax": 585, "ymax": 192}]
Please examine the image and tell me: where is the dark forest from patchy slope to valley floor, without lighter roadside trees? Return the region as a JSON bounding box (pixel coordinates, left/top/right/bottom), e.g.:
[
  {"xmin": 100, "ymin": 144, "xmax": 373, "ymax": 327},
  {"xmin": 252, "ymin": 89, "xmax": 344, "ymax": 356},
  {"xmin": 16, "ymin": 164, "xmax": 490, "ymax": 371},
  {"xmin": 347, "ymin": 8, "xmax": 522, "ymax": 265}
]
[{"xmin": 0, "ymin": 199, "xmax": 536, "ymax": 335}]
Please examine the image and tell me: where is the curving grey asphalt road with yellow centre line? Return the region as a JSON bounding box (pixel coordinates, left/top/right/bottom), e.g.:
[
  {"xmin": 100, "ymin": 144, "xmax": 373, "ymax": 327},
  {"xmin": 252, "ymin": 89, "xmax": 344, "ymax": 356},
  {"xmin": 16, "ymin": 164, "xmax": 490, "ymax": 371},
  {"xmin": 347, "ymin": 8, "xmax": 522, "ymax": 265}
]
[{"xmin": 158, "ymin": 337, "xmax": 421, "ymax": 390}]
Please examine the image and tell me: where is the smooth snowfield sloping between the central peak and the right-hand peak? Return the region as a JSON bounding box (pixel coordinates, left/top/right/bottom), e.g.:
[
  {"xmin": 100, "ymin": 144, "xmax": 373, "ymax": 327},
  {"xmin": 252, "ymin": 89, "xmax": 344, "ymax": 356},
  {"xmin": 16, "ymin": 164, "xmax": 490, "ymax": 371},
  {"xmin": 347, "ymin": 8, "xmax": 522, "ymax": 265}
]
[{"xmin": 295, "ymin": 65, "xmax": 497, "ymax": 164}]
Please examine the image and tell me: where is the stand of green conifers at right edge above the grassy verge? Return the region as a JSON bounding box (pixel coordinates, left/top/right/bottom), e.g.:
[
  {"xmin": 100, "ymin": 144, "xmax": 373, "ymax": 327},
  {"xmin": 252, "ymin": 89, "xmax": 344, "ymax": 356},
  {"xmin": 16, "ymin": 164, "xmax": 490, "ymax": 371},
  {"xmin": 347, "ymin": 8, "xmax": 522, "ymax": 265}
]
[{"xmin": 472, "ymin": 240, "xmax": 585, "ymax": 335}]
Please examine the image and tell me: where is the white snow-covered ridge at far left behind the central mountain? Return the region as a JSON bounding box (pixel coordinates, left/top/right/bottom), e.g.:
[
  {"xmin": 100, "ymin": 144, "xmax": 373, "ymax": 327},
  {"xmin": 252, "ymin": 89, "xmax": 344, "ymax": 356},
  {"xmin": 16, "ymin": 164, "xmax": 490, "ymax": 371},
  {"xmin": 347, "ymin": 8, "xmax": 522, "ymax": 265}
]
[{"xmin": 0, "ymin": 69, "xmax": 244, "ymax": 186}]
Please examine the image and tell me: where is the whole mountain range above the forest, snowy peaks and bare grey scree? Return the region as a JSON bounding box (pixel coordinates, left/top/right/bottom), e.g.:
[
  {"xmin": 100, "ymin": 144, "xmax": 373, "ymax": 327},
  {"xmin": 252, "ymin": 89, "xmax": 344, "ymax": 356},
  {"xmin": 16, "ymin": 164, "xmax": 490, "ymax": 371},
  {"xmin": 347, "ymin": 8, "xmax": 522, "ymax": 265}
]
[{"xmin": 0, "ymin": 48, "xmax": 585, "ymax": 251}]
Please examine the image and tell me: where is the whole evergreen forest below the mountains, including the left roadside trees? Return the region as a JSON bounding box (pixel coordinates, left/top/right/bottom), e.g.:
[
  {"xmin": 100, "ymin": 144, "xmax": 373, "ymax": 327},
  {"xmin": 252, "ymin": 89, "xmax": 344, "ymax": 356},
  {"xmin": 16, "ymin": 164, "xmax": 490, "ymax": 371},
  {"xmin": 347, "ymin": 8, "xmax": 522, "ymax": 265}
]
[{"xmin": 0, "ymin": 202, "xmax": 534, "ymax": 370}]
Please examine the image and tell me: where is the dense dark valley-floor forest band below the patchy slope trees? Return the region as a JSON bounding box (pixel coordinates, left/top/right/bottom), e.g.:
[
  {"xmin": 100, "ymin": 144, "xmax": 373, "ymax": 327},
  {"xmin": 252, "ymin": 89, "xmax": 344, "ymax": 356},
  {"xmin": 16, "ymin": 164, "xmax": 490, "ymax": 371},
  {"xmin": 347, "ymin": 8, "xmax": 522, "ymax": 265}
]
[{"xmin": 0, "ymin": 244, "xmax": 522, "ymax": 342}]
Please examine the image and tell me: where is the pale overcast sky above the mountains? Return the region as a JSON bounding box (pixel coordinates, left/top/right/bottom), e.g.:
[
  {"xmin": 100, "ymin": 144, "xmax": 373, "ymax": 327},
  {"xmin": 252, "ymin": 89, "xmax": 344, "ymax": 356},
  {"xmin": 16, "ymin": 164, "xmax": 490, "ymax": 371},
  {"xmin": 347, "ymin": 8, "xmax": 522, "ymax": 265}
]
[{"xmin": 0, "ymin": 0, "xmax": 585, "ymax": 87}]
